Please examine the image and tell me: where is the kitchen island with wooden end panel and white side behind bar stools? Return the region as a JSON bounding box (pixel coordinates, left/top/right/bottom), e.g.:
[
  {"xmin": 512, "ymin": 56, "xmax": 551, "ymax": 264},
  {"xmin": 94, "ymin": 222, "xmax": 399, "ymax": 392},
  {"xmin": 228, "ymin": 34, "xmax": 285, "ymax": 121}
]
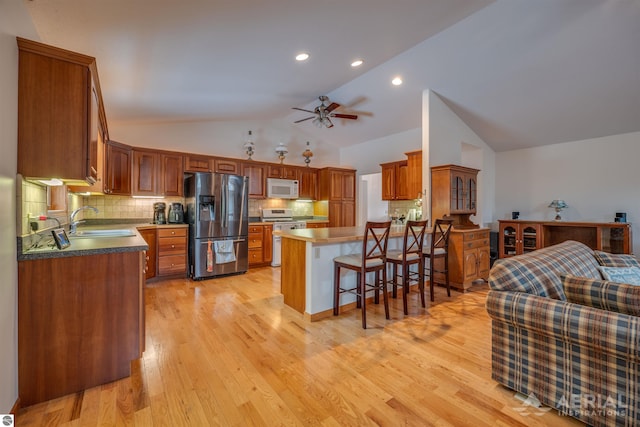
[{"xmin": 278, "ymin": 225, "xmax": 404, "ymax": 321}]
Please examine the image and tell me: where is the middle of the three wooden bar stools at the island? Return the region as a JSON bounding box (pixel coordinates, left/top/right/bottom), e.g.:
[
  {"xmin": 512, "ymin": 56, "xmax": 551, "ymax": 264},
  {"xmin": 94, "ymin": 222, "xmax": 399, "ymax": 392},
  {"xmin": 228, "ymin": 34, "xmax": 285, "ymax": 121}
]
[{"xmin": 387, "ymin": 220, "xmax": 427, "ymax": 315}]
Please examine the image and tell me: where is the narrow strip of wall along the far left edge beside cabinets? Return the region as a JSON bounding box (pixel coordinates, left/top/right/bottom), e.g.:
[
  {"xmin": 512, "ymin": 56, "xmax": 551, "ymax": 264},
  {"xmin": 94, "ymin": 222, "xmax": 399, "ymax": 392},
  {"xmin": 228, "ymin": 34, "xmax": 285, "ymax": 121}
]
[{"xmin": 0, "ymin": 0, "xmax": 38, "ymax": 413}]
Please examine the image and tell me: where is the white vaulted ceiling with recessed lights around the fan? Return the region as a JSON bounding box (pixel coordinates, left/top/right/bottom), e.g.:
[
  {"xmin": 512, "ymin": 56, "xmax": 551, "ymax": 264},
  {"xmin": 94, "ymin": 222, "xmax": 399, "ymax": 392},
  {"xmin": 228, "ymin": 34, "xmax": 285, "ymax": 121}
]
[{"xmin": 25, "ymin": 0, "xmax": 640, "ymax": 151}]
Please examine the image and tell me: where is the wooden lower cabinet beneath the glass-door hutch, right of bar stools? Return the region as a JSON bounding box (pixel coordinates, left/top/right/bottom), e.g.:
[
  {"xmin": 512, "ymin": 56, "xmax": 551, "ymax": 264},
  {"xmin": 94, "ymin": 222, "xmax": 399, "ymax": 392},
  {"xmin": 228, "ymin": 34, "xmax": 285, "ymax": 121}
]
[{"xmin": 449, "ymin": 228, "xmax": 491, "ymax": 291}]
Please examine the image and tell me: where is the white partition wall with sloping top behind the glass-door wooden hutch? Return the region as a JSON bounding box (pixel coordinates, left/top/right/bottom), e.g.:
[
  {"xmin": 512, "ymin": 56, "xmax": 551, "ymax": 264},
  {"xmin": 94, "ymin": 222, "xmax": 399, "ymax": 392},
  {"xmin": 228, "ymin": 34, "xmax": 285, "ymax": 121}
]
[{"xmin": 422, "ymin": 90, "xmax": 496, "ymax": 226}]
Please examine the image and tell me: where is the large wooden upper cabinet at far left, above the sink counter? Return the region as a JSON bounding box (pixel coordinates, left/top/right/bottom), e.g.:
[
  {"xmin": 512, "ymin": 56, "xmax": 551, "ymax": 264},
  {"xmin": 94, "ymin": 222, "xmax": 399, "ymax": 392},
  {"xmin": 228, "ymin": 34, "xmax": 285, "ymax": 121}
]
[{"xmin": 17, "ymin": 37, "xmax": 108, "ymax": 185}]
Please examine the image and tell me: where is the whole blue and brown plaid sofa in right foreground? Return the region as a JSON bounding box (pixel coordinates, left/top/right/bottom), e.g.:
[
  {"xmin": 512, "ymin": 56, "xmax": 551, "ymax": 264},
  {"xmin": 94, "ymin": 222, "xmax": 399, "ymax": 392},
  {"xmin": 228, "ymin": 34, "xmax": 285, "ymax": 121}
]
[{"xmin": 486, "ymin": 241, "xmax": 640, "ymax": 426}]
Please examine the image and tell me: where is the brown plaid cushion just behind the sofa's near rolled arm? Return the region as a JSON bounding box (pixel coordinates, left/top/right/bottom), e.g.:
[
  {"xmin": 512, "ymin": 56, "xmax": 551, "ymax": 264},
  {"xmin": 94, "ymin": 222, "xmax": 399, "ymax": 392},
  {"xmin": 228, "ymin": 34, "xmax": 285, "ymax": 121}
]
[{"xmin": 560, "ymin": 274, "xmax": 640, "ymax": 316}]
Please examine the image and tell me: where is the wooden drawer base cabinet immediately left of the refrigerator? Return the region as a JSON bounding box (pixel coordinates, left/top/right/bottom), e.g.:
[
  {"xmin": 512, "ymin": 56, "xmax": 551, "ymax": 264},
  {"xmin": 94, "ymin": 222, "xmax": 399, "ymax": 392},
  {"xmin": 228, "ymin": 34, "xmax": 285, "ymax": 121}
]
[{"xmin": 157, "ymin": 227, "xmax": 189, "ymax": 277}]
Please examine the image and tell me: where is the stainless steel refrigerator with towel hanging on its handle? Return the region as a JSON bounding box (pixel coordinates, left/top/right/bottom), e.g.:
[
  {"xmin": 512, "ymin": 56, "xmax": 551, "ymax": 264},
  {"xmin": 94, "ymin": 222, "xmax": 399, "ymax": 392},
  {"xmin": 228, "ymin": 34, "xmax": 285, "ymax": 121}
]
[{"xmin": 184, "ymin": 172, "xmax": 249, "ymax": 279}]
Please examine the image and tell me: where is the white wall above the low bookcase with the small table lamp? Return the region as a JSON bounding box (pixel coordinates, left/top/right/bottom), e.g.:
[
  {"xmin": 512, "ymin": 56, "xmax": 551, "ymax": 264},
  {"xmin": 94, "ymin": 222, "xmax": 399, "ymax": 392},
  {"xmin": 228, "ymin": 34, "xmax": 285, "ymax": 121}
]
[{"xmin": 494, "ymin": 132, "xmax": 640, "ymax": 254}]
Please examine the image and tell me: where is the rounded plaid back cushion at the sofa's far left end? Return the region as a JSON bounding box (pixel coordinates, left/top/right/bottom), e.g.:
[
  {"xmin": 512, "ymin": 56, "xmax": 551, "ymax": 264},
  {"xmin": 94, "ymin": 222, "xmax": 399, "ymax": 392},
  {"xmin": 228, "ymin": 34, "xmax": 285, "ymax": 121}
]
[{"xmin": 489, "ymin": 240, "xmax": 601, "ymax": 301}]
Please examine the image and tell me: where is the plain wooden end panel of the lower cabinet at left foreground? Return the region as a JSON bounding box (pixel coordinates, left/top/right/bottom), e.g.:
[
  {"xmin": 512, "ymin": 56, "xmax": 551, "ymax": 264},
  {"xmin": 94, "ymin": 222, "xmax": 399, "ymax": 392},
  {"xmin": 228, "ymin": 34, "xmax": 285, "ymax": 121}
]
[{"xmin": 17, "ymin": 251, "xmax": 145, "ymax": 407}]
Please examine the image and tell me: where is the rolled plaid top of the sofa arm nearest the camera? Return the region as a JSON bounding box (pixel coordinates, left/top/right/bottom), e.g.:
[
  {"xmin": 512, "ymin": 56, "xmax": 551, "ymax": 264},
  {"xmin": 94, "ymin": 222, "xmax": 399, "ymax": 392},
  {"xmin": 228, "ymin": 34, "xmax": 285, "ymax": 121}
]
[{"xmin": 486, "ymin": 290, "xmax": 640, "ymax": 361}]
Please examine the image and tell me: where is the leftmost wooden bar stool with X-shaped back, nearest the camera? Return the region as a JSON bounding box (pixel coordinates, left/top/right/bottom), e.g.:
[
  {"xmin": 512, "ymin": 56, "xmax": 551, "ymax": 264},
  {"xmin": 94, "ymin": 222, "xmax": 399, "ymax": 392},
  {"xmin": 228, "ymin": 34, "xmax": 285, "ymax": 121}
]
[{"xmin": 333, "ymin": 221, "xmax": 391, "ymax": 329}]
